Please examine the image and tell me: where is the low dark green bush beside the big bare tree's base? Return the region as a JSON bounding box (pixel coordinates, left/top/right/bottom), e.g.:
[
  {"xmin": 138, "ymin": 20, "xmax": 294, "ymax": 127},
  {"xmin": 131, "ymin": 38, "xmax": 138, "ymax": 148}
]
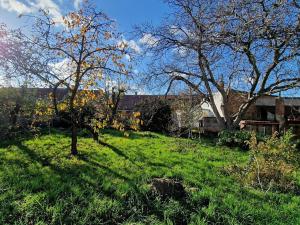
[{"xmin": 218, "ymin": 130, "xmax": 251, "ymax": 150}]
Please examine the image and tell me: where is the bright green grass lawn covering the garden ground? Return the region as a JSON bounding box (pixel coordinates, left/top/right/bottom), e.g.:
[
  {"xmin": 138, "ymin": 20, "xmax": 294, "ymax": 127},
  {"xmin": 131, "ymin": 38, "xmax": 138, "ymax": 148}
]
[{"xmin": 0, "ymin": 128, "xmax": 300, "ymax": 225}]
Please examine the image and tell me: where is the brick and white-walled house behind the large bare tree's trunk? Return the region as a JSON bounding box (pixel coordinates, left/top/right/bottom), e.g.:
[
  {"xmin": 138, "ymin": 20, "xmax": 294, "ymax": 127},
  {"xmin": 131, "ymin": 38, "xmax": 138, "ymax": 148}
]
[{"xmin": 200, "ymin": 90, "xmax": 300, "ymax": 135}]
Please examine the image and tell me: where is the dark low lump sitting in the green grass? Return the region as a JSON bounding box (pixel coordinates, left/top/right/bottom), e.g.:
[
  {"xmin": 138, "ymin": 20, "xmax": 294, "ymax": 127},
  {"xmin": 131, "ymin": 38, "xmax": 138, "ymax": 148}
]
[{"xmin": 151, "ymin": 178, "xmax": 186, "ymax": 200}]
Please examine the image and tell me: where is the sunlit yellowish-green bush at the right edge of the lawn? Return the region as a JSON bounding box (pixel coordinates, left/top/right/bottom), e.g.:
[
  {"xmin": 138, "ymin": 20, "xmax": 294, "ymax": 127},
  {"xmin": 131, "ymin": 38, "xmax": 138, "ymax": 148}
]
[{"xmin": 229, "ymin": 131, "xmax": 300, "ymax": 192}]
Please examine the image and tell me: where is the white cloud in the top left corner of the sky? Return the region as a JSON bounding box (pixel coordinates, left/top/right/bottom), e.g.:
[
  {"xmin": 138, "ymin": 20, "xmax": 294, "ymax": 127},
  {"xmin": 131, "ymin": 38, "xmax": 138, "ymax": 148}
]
[{"xmin": 0, "ymin": 0, "xmax": 62, "ymax": 23}]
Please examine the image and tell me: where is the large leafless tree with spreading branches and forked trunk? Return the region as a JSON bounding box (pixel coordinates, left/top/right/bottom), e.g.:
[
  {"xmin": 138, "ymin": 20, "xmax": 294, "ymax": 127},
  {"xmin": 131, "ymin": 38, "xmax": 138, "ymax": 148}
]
[{"xmin": 137, "ymin": 0, "xmax": 300, "ymax": 129}]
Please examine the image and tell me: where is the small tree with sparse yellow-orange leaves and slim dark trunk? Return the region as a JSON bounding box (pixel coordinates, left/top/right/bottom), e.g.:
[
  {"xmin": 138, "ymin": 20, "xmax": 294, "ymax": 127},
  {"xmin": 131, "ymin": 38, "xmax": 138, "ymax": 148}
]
[{"xmin": 0, "ymin": 3, "xmax": 129, "ymax": 155}]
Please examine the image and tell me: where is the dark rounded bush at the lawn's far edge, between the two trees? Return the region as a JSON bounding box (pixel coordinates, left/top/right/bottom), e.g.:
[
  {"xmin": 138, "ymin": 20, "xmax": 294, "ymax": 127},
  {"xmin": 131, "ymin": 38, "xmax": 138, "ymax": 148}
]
[{"xmin": 135, "ymin": 99, "xmax": 172, "ymax": 132}]
